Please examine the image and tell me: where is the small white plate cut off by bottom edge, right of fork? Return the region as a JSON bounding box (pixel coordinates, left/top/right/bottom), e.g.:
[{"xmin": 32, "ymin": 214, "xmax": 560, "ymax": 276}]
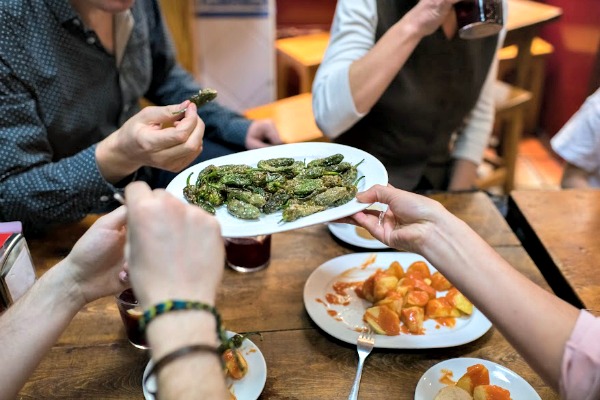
[{"xmin": 415, "ymin": 358, "xmax": 541, "ymax": 400}]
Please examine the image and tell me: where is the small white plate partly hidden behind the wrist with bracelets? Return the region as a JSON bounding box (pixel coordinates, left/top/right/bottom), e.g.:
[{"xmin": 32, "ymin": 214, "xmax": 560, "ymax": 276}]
[{"xmin": 142, "ymin": 331, "xmax": 267, "ymax": 400}]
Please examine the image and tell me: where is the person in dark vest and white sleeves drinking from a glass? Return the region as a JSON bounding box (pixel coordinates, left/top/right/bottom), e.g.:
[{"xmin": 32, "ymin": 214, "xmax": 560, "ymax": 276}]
[{"xmin": 312, "ymin": 0, "xmax": 506, "ymax": 191}]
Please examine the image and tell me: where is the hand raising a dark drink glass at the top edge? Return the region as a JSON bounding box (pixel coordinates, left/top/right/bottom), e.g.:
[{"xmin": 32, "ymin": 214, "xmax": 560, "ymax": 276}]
[{"xmin": 404, "ymin": 0, "xmax": 461, "ymax": 36}]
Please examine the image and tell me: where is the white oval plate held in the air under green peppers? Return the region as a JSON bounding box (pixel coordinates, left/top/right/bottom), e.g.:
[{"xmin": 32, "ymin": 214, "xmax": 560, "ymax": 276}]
[{"xmin": 167, "ymin": 142, "xmax": 388, "ymax": 237}]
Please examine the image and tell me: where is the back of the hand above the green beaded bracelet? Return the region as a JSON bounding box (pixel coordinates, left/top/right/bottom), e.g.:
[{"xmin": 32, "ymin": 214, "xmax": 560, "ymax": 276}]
[{"xmin": 125, "ymin": 182, "xmax": 225, "ymax": 308}]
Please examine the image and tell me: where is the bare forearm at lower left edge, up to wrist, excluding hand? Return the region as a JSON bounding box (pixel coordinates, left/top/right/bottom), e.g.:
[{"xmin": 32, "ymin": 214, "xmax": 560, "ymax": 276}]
[{"xmin": 0, "ymin": 262, "xmax": 83, "ymax": 399}]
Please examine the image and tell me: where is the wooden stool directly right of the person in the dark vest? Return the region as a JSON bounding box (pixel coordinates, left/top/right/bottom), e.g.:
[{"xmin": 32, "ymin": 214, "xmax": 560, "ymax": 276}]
[{"xmin": 476, "ymin": 81, "xmax": 532, "ymax": 194}]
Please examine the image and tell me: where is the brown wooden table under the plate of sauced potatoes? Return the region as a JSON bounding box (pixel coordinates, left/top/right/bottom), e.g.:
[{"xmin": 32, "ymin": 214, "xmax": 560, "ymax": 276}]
[{"xmin": 20, "ymin": 193, "xmax": 558, "ymax": 400}]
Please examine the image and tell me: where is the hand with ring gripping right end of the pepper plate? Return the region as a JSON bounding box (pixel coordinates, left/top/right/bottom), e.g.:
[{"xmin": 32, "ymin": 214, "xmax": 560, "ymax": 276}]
[{"xmin": 340, "ymin": 185, "xmax": 446, "ymax": 254}]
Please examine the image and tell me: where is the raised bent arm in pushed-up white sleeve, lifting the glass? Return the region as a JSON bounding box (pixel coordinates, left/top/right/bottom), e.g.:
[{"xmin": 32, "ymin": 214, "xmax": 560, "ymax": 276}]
[{"xmin": 313, "ymin": 0, "xmax": 457, "ymax": 138}]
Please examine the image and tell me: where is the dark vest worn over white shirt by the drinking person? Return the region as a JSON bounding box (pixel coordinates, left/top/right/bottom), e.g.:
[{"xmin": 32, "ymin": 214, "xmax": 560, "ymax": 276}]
[{"xmin": 335, "ymin": 0, "xmax": 498, "ymax": 190}]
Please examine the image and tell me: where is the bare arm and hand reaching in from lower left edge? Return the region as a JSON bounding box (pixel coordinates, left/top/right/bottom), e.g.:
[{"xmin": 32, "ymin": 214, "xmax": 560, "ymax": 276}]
[{"xmin": 0, "ymin": 208, "xmax": 126, "ymax": 399}]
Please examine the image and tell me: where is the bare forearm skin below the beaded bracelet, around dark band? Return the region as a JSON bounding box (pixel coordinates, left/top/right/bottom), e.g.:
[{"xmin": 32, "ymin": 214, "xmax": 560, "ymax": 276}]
[{"xmin": 147, "ymin": 311, "xmax": 227, "ymax": 399}]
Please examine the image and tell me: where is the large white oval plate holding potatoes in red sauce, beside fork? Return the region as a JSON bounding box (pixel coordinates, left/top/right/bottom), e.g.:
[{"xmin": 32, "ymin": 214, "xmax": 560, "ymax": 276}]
[{"xmin": 304, "ymin": 252, "xmax": 492, "ymax": 349}]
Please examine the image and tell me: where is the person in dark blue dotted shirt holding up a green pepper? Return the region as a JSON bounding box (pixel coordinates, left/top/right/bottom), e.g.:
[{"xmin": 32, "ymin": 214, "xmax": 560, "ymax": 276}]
[{"xmin": 0, "ymin": 0, "xmax": 281, "ymax": 233}]
